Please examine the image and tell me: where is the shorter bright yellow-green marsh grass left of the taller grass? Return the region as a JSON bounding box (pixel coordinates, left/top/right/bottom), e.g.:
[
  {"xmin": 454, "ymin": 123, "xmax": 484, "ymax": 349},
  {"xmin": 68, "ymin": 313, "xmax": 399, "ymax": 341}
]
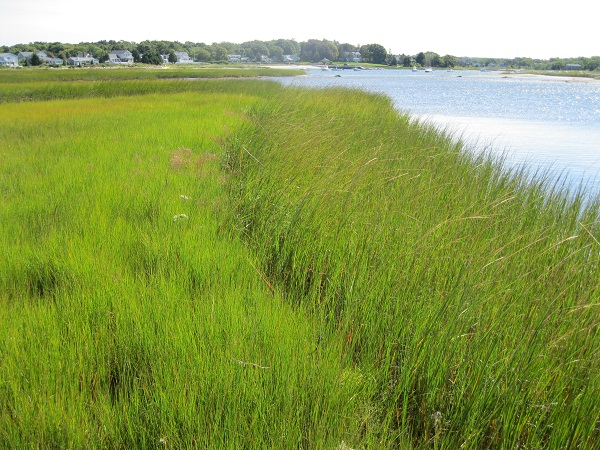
[{"xmin": 0, "ymin": 81, "xmax": 360, "ymax": 449}]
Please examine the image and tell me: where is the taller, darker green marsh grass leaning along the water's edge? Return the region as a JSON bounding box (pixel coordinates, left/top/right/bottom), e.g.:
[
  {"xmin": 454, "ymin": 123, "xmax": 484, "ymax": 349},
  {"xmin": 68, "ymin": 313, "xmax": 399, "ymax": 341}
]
[{"xmin": 229, "ymin": 89, "xmax": 600, "ymax": 449}]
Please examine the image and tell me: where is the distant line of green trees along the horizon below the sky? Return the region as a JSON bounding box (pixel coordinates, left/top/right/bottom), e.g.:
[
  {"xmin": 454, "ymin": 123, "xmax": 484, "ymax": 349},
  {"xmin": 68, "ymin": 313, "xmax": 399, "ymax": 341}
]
[{"xmin": 0, "ymin": 39, "xmax": 600, "ymax": 70}]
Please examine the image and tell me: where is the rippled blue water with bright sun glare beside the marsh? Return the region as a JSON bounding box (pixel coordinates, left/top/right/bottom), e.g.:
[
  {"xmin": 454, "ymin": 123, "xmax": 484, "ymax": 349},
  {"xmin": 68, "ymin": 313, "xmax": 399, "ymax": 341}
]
[{"xmin": 282, "ymin": 70, "xmax": 600, "ymax": 197}]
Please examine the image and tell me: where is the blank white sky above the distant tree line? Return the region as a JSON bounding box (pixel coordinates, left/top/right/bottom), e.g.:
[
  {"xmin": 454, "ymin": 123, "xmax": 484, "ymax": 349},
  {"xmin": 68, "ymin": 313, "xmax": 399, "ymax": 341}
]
[{"xmin": 0, "ymin": 0, "xmax": 600, "ymax": 59}]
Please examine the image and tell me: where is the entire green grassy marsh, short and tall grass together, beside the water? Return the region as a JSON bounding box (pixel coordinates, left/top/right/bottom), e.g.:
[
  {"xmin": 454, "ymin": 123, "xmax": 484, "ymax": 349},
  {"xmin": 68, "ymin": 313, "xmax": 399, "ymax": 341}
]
[{"xmin": 0, "ymin": 71, "xmax": 600, "ymax": 450}]
